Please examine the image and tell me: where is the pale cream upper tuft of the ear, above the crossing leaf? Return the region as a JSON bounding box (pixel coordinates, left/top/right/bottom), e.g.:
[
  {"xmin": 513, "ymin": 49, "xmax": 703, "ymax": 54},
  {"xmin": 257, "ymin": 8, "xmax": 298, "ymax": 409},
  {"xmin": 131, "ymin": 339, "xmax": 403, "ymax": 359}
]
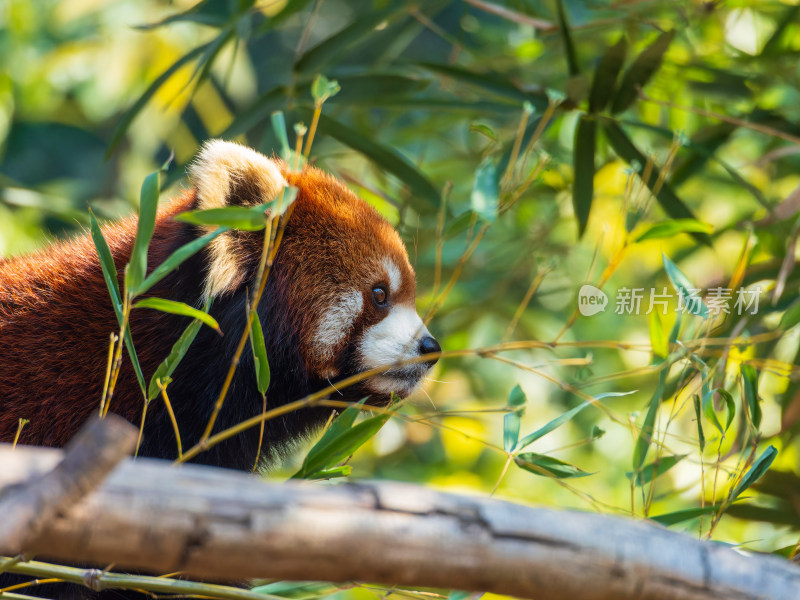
[{"xmin": 189, "ymin": 140, "xmax": 286, "ymax": 209}]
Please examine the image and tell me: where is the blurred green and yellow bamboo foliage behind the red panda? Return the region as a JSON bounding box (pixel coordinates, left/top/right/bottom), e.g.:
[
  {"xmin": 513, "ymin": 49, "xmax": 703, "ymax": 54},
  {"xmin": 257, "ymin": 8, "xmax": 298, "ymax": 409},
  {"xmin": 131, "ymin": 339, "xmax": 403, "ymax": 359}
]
[{"xmin": 0, "ymin": 0, "xmax": 800, "ymax": 594}]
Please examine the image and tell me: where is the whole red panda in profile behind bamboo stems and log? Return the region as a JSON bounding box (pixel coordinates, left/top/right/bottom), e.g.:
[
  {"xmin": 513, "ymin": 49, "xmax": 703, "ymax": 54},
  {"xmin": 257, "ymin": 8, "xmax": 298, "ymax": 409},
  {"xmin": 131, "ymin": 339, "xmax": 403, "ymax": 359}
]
[{"xmin": 0, "ymin": 140, "xmax": 440, "ymax": 469}]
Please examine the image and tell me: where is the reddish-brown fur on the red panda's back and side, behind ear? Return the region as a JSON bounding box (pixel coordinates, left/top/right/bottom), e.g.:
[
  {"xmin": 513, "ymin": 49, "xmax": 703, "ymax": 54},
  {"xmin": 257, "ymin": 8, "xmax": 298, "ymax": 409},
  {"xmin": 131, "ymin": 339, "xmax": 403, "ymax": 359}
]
[{"xmin": 0, "ymin": 193, "xmax": 194, "ymax": 446}]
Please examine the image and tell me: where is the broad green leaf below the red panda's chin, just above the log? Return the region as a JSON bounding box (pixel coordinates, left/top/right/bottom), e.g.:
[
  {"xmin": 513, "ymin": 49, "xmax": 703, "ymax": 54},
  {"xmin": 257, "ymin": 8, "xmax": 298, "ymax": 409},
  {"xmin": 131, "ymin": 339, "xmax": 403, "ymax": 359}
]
[{"xmin": 292, "ymin": 409, "xmax": 391, "ymax": 479}]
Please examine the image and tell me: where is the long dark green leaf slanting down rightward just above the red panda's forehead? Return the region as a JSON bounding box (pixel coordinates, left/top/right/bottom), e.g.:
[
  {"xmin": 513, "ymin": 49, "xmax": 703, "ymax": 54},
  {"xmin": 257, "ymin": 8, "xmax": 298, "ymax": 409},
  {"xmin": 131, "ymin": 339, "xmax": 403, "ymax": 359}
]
[{"xmin": 309, "ymin": 114, "xmax": 440, "ymax": 213}]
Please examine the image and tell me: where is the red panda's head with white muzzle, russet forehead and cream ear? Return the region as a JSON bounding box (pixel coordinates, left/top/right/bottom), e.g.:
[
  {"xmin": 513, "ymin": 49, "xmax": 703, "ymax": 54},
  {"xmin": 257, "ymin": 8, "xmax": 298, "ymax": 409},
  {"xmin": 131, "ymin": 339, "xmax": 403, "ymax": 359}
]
[{"xmin": 190, "ymin": 141, "xmax": 440, "ymax": 402}]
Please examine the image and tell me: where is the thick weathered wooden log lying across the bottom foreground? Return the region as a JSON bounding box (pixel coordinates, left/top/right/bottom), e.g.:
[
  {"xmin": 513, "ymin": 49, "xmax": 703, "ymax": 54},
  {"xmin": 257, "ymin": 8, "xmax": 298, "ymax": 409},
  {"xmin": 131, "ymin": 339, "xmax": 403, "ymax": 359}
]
[{"xmin": 0, "ymin": 447, "xmax": 800, "ymax": 600}]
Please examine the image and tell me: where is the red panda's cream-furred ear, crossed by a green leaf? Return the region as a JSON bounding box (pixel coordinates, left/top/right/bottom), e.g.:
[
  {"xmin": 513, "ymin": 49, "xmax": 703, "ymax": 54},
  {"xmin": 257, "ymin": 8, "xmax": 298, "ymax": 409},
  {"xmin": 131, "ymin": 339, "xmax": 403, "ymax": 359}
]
[{"xmin": 189, "ymin": 140, "xmax": 287, "ymax": 298}]
